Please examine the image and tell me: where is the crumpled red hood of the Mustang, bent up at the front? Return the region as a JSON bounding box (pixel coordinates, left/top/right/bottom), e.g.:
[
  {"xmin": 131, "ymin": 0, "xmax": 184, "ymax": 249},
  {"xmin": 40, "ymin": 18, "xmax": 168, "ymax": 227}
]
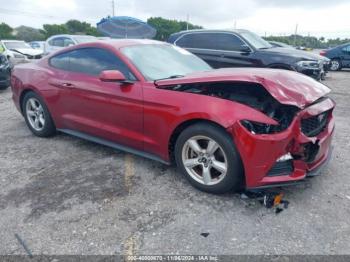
[{"xmin": 156, "ymin": 68, "xmax": 330, "ymax": 108}]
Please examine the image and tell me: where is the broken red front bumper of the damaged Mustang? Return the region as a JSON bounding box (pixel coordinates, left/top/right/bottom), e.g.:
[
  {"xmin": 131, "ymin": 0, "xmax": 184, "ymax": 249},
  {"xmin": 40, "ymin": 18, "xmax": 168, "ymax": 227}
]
[{"xmin": 232, "ymin": 98, "xmax": 335, "ymax": 189}]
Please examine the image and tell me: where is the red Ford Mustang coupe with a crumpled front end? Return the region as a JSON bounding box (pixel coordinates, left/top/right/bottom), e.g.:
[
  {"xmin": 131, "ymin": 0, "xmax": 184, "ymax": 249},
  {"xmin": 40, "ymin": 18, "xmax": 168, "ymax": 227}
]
[{"xmin": 11, "ymin": 40, "xmax": 335, "ymax": 193}]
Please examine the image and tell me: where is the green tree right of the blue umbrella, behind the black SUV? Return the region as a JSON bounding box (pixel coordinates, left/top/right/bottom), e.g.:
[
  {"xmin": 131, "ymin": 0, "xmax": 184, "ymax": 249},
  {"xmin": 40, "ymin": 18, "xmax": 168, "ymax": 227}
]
[{"xmin": 147, "ymin": 17, "xmax": 203, "ymax": 41}]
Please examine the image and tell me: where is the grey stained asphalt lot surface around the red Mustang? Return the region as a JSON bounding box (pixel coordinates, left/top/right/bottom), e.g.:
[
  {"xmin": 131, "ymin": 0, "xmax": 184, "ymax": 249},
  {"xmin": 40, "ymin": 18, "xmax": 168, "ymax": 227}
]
[{"xmin": 0, "ymin": 71, "xmax": 350, "ymax": 255}]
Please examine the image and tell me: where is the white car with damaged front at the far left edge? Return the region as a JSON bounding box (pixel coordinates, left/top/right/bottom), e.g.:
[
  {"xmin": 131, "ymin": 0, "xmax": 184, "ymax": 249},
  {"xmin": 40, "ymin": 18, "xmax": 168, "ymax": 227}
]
[{"xmin": 0, "ymin": 40, "xmax": 43, "ymax": 65}]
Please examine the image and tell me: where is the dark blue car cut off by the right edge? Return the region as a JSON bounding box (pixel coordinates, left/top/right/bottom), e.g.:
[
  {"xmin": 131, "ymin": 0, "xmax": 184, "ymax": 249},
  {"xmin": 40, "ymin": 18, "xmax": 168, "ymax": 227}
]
[{"xmin": 320, "ymin": 43, "xmax": 350, "ymax": 71}]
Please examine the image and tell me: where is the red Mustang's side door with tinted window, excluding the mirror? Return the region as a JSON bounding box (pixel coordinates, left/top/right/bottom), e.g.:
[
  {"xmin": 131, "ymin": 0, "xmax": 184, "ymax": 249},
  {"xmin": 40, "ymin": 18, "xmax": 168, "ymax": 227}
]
[{"xmin": 51, "ymin": 48, "xmax": 143, "ymax": 150}]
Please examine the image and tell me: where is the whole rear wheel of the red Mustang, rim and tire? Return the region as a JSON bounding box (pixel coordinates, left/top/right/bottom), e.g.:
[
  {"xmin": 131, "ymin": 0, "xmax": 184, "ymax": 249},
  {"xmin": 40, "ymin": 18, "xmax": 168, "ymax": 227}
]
[{"xmin": 22, "ymin": 92, "xmax": 56, "ymax": 137}]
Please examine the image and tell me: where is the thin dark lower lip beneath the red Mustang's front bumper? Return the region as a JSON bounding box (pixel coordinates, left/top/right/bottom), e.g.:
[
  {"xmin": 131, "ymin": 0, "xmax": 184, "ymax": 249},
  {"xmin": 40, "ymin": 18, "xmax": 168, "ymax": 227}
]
[{"xmin": 246, "ymin": 146, "xmax": 334, "ymax": 191}]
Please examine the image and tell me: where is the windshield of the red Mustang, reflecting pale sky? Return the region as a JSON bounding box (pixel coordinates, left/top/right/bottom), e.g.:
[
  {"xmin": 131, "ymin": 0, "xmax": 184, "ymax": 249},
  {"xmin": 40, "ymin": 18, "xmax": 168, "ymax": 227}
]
[{"xmin": 122, "ymin": 44, "xmax": 211, "ymax": 80}]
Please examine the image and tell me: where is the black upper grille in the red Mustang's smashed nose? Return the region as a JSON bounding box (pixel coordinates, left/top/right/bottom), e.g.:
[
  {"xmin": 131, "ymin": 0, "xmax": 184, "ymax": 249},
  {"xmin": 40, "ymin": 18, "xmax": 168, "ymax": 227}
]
[{"xmin": 301, "ymin": 111, "xmax": 330, "ymax": 137}]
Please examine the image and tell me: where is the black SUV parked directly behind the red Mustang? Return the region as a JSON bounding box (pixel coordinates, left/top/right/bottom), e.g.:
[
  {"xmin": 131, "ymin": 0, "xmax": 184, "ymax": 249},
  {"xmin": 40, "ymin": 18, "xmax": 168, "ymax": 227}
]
[{"xmin": 168, "ymin": 30, "xmax": 329, "ymax": 79}]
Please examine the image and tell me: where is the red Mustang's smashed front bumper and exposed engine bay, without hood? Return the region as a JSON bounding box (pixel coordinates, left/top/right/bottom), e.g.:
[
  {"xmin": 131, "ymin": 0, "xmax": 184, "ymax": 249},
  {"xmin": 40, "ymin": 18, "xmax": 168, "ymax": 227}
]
[{"xmin": 157, "ymin": 82, "xmax": 335, "ymax": 189}]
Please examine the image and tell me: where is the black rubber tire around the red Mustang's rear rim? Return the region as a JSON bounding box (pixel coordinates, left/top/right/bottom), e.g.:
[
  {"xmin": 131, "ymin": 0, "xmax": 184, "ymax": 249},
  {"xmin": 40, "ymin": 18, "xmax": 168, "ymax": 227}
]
[{"xmin": 22, "ymin": 92, "xmax": 56, "ymax": 137}]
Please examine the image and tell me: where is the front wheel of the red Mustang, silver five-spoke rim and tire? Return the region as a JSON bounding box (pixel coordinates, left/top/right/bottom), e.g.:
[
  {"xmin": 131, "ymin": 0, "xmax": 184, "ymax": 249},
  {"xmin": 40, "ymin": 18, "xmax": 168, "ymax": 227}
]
[{"xmin": 175, "ymin": 123, "xmax": 243, "ymax": 194}]
